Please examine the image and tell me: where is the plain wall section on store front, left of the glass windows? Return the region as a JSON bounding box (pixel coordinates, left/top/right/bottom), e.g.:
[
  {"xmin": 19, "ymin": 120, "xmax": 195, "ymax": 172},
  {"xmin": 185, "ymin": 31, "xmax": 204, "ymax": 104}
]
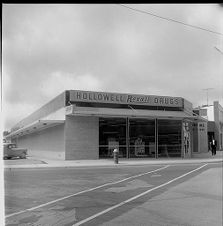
[{"xmin": 65, "ymin": 116, "xmax": 99, "ymax": 160}]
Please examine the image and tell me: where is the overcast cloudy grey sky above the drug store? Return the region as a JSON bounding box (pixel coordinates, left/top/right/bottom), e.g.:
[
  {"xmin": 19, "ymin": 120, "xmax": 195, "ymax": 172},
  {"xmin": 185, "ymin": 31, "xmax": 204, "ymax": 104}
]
[{"xmin": 2, "ymin": 4, "xmax": 223, "ymax": 130}]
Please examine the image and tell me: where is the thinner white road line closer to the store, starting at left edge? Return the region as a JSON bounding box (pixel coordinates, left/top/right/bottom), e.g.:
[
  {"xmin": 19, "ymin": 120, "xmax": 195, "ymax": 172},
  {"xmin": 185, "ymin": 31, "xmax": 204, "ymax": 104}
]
[{"xmin": 5, "ymin": 165, "xmax": 169, "ymax": 218}]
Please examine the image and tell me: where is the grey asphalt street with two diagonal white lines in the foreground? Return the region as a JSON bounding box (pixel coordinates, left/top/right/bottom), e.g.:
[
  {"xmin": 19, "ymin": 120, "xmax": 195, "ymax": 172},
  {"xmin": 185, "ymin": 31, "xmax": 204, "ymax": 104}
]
[{"xmin": 5, "ymin": 163, "xmax": 222, "ymax": 226}]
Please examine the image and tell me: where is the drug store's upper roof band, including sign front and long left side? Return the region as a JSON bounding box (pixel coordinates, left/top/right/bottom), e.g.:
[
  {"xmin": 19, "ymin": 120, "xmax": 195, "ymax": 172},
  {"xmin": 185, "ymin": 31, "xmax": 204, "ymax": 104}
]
[{"xmin": 8, "ymin": 90, "xmax": 192, "ymax": 132}]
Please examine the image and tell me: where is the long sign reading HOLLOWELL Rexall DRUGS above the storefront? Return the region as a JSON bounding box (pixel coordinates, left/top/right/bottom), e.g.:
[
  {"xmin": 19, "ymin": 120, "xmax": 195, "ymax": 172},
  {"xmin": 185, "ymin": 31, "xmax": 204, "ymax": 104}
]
[{"xmin": 70, "ymin": 90, "xmax": 183, "ymax": 107}]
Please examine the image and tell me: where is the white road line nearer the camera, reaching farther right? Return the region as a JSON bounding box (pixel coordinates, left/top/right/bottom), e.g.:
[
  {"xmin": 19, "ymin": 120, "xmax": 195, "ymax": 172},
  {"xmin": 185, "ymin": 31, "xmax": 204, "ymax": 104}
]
[{"xmin": 72, "ymin": 163, "xmax": 208, "ymax": 226}]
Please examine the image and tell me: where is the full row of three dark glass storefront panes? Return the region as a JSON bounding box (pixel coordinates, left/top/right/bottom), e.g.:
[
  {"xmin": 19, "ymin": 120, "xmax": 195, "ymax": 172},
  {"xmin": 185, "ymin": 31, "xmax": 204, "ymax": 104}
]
[{"xmin": 99, "ymin": 118, "xmax": 182, "ymax": 158}]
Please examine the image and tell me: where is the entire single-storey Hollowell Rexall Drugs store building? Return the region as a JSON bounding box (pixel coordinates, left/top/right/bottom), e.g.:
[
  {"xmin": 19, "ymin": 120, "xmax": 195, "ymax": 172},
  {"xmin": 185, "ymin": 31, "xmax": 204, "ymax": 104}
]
[{"xmin": 6, "ymin": 90, "xmax": 208, "ymax": 160}]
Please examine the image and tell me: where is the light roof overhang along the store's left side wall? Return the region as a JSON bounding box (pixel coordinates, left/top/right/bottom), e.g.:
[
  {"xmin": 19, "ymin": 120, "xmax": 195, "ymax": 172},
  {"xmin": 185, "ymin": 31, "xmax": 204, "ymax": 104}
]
[{"xmin": 5, "ymin": 120, "xmax": 65, "ymax": 139}]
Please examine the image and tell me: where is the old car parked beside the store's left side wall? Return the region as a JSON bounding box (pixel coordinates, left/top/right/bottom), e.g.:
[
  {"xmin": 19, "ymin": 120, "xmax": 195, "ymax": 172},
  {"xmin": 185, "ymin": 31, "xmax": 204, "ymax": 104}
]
[{"xmin": 3, "ymin": 143, "xmax": 27, "ymax": 159}]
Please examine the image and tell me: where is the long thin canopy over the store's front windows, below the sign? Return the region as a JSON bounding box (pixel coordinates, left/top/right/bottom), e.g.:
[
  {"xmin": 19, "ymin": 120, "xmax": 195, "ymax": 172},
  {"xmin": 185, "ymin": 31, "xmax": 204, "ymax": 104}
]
[{"xmin": 66, "ymin": 105, "xmax": 206, "ymax": 121}]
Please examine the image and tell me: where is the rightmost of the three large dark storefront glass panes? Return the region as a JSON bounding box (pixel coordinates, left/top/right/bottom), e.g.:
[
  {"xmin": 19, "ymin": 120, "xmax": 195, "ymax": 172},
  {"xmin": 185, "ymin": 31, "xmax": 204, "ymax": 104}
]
[{"xmin": 157, "ymin": 119, "xmax": 182, "ymax": 157}]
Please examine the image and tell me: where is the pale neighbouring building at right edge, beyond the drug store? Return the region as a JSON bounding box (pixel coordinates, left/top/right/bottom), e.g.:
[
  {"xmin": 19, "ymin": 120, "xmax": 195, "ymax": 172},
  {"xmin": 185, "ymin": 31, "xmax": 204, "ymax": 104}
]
[{"xmin": 193, "ymin": 101, "xmax": 223, "ymax": 150}]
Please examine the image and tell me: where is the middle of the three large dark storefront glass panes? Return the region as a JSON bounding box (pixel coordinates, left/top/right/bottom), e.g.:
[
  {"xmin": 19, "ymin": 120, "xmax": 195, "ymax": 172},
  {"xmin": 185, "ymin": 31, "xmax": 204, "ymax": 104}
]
[{"xmin": 129, "ymin": 118, "xmax": 155, "ymax": 158}]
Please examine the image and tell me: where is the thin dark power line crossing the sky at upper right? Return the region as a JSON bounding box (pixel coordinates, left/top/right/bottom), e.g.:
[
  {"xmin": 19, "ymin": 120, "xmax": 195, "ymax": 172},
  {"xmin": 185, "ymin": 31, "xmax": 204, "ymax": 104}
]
[{"xmin": 117, "ymin": 4, "xmax": 223, "ymax": 36}]
